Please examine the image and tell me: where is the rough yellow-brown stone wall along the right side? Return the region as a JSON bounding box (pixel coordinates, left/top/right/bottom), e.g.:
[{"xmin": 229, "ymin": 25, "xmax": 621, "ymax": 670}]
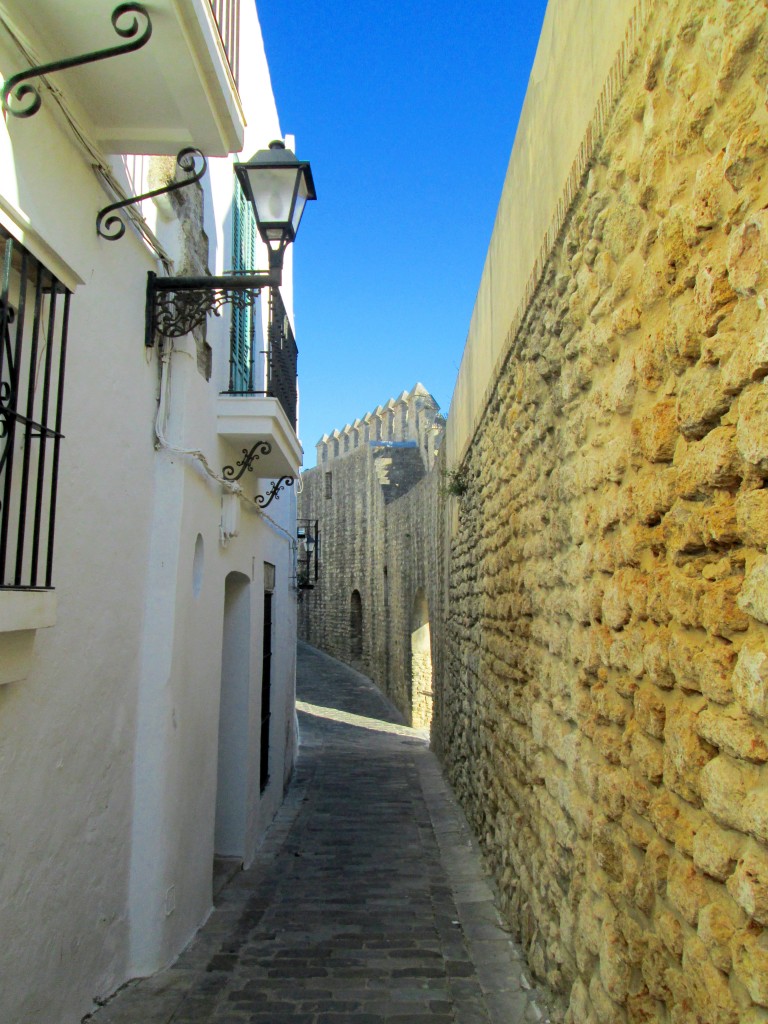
[{"xmin": 437, "ymin": 0, "xmax": 768, "ymax": 1024}]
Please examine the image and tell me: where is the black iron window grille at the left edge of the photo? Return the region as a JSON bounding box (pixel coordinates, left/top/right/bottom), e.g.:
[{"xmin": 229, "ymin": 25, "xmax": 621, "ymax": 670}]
[{"xmin": 0, "ymin": 228, "xmax": 70, "ymax": 589}]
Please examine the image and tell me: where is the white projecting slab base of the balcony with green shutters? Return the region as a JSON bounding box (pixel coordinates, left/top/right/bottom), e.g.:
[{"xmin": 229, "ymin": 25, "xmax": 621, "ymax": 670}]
[{"xmin": 216, "ymin": 394, "xmax": 303, "ymax": 483}]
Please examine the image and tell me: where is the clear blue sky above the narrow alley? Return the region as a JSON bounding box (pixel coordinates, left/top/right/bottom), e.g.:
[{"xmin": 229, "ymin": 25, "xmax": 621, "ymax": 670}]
[{"xmin": 257, "ymin": 0, "xmax": 547, "ymax": 467}]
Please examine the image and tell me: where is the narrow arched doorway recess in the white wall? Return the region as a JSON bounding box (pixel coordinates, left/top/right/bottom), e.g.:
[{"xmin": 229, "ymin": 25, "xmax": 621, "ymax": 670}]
[{"xmin": 213, "ymin": 572, "xmax": 251, "ymax": 870}]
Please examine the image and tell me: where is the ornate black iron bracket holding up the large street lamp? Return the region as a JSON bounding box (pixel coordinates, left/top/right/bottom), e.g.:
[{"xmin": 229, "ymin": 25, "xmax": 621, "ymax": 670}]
[{"xmin": 144, "ymin": 270, "xmax": 282, "ymax": 348}]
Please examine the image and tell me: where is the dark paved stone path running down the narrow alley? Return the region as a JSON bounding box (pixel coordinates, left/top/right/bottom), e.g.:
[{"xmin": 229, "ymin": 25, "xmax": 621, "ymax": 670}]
[{"xmin": 89, "ymin": 644, "xmax": 547, "ymax": 1024}]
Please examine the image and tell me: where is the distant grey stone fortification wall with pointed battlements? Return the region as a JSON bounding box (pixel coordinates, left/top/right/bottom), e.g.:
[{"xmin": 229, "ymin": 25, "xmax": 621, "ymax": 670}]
[{"xmin": 299, "ymin": 385, "xmax": 443, "ymax": 726}]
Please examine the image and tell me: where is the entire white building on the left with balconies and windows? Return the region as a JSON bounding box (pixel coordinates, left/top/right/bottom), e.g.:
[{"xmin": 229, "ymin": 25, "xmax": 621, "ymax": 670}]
[{"xmin": 0, "ymin": 0, "xmax": 301, "ymax": 1024}]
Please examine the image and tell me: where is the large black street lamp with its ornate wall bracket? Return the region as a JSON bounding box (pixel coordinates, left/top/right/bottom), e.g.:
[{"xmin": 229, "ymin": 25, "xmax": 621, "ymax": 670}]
[{"xmin": 144, "ymin": 141, "xmax": 317, "ymax": 348}]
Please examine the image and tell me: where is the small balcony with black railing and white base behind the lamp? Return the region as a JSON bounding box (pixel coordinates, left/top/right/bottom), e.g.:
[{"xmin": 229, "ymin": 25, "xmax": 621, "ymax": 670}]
[{"xmin": 217, "ymin": 288, "xmax": 303, "ymax": 479}]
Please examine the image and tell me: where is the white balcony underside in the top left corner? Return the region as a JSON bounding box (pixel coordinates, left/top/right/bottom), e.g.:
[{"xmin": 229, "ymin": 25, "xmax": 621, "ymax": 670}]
[{"xmin": 0, "ymin": 0, "xmax": 245, "ymax": 157}]
